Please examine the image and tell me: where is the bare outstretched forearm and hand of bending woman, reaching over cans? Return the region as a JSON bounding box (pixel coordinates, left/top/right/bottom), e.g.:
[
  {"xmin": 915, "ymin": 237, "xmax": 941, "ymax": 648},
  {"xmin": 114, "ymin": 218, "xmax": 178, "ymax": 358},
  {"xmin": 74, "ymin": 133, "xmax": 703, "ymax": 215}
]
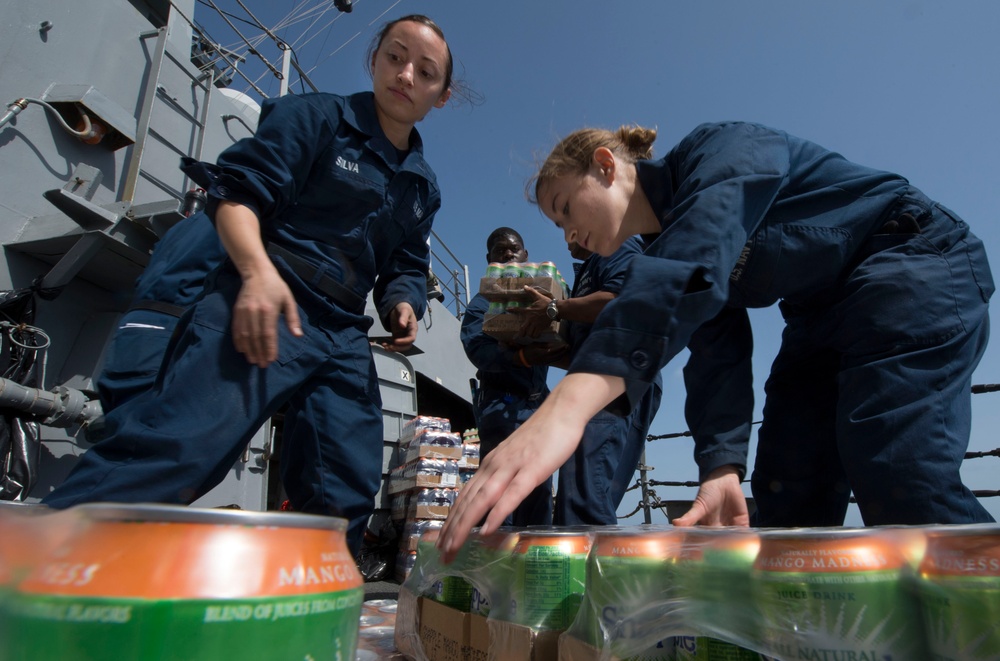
[{"xmin": 438, "ymin": 372, "xmax": 625, "ymax": 562}]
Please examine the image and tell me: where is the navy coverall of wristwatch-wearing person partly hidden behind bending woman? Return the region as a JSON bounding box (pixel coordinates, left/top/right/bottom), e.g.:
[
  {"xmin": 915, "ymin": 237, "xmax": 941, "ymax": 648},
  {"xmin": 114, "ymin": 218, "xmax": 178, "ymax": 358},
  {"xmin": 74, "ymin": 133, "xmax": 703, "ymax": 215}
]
[{"xmin": 553, "ymin": 237, "xmax": 663, "ymax": 526}]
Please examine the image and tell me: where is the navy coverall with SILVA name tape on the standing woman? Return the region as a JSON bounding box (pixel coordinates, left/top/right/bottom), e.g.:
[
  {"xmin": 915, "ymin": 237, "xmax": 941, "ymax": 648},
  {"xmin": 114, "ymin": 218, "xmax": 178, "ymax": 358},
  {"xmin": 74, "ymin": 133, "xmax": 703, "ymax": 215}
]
[{"xmin": 44, "ymin": 92, "xmax": 441, "ymax": 552}]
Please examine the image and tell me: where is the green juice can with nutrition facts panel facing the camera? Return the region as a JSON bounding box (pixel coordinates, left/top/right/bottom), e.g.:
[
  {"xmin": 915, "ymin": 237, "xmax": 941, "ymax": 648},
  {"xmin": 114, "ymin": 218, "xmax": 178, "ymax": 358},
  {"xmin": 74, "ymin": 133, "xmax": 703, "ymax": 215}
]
[{"xmin": 505, "ymin": 529, "xmax": 591, "ymax": 631}]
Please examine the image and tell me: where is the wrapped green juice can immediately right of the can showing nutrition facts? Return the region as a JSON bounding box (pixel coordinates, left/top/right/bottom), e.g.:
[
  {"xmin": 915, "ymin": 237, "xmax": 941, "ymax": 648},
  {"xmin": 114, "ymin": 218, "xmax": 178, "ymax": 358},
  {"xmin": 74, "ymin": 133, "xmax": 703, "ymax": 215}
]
[{"xmin": 568, "ymin": 527, "xmax": 685, "ymax": 661}]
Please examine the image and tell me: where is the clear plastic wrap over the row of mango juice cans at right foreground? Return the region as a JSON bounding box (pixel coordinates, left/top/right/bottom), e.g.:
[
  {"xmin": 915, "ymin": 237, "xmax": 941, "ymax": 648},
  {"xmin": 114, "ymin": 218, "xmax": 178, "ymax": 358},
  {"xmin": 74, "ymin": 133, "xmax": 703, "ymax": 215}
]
[{"xmin": 397, "ymin": 524, "xmax": 1000, "ymax": 661}]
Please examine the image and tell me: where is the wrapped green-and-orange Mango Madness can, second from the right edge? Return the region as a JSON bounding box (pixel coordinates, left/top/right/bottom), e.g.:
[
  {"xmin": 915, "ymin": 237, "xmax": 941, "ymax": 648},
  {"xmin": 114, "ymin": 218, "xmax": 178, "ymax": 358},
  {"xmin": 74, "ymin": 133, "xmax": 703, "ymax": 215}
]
[{"xmin": 752, "ymin": 528, "xmax": 925, "ymax": 661}]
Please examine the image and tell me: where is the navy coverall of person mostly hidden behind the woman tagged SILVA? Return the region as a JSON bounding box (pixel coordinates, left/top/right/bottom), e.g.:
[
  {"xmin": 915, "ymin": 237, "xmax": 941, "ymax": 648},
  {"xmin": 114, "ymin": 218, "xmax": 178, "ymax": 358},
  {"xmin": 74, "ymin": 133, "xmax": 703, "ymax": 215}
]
[{"xmin": 95, "ymin": 212, "xmax": 226, "ymax": 415}]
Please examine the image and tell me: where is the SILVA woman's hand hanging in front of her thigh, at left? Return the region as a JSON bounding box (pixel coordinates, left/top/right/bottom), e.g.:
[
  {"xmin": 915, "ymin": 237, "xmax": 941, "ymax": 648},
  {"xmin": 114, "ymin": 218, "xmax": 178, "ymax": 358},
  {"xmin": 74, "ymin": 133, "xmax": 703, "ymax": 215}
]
[{"xmin": 233, "ymin": 267, "xmax": 302, "ymax": 368}]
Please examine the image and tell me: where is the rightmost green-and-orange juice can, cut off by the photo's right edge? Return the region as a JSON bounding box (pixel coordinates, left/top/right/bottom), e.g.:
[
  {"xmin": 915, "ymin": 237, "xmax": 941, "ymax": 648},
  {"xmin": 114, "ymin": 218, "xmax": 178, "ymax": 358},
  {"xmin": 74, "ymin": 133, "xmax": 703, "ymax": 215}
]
[{"xmin": 918, "ymin": 524, "xmax": 1000, "ymax": 661}]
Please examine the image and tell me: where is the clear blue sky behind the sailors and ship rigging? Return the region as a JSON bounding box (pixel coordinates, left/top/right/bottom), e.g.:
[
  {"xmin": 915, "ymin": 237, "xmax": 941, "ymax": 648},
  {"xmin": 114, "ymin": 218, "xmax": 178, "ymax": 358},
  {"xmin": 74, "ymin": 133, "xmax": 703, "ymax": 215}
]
[{"xmin": 196, "ymin": 0, "xmax": 1000, "ymax": 523}]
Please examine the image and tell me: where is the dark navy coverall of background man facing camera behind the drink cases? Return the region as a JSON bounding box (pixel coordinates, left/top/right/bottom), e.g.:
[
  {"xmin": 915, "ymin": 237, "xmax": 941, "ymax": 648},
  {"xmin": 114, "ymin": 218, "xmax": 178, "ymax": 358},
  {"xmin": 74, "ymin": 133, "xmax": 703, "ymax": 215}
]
[{"xmin": 461, "ymin": 294, "xmax": 552, "ymax": 526}]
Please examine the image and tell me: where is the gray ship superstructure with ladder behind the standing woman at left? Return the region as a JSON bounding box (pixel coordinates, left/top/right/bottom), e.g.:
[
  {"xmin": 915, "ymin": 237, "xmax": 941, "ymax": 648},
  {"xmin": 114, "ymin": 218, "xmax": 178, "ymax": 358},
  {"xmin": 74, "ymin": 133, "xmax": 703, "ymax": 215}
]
[{"xmin": 0, "ymin": 0, "xmax": 475, "ymax": 517}]
